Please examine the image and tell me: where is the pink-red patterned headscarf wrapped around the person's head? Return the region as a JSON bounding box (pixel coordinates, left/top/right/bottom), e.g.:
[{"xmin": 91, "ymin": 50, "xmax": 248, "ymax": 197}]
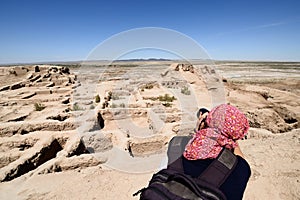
[{"xmin": 183, "ymin": 104, "xmax": 249, "ymax": 160}]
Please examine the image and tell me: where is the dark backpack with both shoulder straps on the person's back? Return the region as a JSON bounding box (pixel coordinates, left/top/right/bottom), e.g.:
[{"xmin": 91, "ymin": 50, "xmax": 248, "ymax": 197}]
[{"xmin": 134, "ymin": 136, "xmax": 237, "ymax": 200}]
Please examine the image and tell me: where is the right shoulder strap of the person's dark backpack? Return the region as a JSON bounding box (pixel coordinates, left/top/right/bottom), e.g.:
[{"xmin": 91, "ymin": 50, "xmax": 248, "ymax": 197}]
[{"xmin": 198, "ymin": 148, "xmax": 238, "ymax": 187}]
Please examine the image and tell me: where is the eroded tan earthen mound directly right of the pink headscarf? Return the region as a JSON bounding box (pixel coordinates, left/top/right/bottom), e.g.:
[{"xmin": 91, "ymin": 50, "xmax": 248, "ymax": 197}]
[{"xmin": 228, "ymin": 83, "xmax": 299, "ymax": 133}]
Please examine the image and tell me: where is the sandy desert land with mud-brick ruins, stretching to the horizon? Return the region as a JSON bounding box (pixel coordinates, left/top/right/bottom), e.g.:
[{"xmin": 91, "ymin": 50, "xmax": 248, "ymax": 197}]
[{"xmin": 0, "ymin": 60, "xmax": 300, "ymax": 200}]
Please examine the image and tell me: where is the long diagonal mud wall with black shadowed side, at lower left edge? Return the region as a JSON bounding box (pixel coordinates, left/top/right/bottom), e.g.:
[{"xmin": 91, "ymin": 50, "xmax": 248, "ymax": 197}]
[{"xmin": 0, "ymin": 138, "xmax": 63, "ymax": 182}]
